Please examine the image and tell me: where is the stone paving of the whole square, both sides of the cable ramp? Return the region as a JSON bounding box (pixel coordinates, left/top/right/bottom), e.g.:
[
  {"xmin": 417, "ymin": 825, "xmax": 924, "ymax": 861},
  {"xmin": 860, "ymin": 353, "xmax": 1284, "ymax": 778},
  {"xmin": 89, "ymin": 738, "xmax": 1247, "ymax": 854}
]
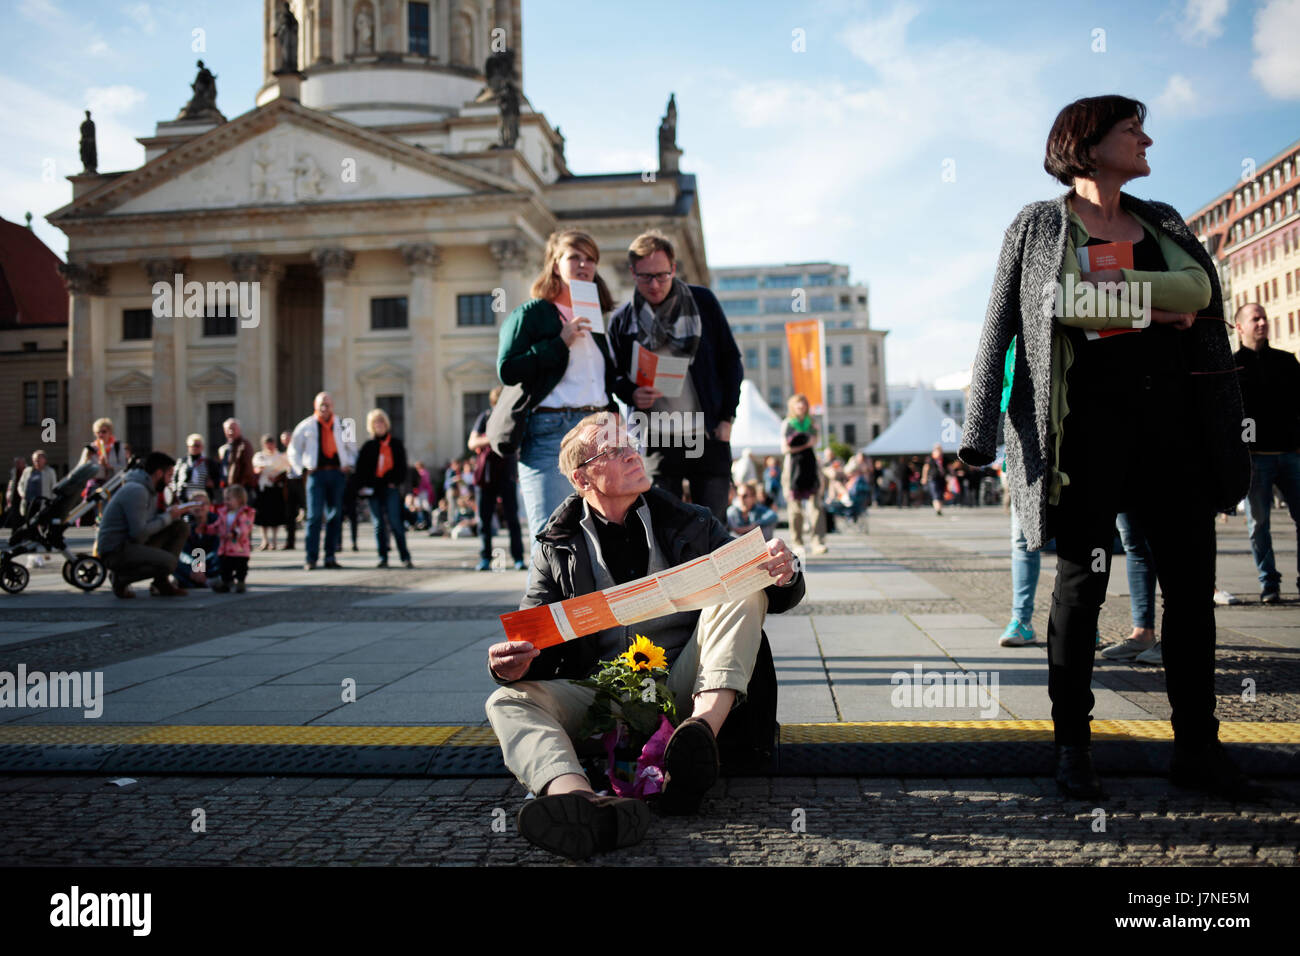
[{"xmin": 0, "ymin": 509, "xmax": 1300, "ymax": 865}]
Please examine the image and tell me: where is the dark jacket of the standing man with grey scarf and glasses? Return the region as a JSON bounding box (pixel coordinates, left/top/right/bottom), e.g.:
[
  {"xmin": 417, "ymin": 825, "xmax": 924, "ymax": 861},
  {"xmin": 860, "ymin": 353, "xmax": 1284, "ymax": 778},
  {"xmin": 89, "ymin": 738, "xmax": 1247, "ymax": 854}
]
[{"xmin": 607, "ymin": 285, "xmax": 745, "ymax": 434}]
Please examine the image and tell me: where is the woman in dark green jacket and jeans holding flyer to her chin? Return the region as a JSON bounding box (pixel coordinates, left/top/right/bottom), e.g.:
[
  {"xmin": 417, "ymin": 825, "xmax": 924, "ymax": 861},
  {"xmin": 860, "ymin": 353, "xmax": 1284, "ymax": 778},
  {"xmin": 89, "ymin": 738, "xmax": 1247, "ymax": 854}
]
[{"xmin": 497, "ymin": 229, "xmax": 632, "ymax": 546}]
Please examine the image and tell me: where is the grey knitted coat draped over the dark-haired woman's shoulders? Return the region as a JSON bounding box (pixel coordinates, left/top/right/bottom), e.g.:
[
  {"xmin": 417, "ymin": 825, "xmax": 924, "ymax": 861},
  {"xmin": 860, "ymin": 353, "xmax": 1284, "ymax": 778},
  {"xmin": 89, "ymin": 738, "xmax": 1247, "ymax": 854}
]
[{"xmin": 958, "ymin": 193, "xmax": 1251, "ymax": 550}]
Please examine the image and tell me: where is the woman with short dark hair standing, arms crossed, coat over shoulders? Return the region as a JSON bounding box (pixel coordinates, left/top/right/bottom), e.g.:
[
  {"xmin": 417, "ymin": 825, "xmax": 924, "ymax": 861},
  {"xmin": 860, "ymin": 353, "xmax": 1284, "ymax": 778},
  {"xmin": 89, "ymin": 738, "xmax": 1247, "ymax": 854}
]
[{"xmin": 961, "ymin": 96, "xmax": 1255, "ymax": 800}]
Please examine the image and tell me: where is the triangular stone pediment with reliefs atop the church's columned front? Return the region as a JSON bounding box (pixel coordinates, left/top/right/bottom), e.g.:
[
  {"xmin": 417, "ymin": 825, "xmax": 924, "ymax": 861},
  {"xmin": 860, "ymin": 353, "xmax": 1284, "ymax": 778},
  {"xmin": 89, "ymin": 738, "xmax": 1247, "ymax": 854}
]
[{"xmin": 49, "ymin": 100, "xmax": 519, "ymax": 221}]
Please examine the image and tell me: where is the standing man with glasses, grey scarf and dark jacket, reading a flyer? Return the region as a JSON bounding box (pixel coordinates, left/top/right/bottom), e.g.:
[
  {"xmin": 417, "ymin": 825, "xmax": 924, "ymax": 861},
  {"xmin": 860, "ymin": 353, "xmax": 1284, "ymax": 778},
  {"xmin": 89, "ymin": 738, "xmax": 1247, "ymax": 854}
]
[{"xmin": 608, "ymin": 232, "xmax": 745, "ymax": 525}]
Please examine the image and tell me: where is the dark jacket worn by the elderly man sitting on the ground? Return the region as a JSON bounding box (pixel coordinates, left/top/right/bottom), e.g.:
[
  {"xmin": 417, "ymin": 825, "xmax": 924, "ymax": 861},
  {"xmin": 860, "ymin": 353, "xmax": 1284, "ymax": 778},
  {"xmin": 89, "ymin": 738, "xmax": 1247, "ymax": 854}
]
[{"xmin": 498, "ymin": 488, "xmax": 805, "ymax": 683}]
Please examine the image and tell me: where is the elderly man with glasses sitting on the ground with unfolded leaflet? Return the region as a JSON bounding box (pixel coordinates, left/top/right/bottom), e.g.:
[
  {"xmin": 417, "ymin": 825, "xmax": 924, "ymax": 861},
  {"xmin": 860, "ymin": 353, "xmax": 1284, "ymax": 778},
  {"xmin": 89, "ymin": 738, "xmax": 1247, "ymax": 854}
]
[{"xmin": 488, "ymin": 412, "xmax": 803, "ymax": 860}]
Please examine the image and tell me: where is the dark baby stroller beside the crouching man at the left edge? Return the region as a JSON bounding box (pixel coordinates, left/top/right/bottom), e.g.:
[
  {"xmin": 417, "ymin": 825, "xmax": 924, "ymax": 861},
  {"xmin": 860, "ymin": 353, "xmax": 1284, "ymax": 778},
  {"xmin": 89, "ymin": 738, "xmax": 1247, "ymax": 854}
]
[{"xmin": 0, "ymin": 462, "xmax": 115, "ymax": 594}]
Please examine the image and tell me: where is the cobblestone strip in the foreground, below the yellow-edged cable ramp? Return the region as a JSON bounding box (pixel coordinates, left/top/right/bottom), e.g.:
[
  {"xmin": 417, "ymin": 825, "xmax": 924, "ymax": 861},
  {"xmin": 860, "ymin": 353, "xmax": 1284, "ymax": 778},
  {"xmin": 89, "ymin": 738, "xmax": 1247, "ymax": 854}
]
[{"xmin": 0, "ymin": 777, "xmax": 1300, "ymax": 866}]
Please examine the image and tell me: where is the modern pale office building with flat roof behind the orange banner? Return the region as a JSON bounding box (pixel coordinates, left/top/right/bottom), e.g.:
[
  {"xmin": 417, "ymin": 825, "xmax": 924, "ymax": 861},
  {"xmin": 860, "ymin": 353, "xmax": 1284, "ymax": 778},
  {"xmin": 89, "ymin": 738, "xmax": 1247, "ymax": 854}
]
[{"xmin": 712, "ymin": 263, "xmax": 888, "ymax": 447}]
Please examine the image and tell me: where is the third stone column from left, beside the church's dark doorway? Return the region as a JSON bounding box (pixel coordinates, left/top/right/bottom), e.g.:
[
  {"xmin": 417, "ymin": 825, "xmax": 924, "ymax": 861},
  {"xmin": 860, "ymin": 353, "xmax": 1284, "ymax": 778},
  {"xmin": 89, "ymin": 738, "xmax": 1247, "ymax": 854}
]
[{"xmin": 230, "ymin": 252, "xmax": 283, "ymax": 434}]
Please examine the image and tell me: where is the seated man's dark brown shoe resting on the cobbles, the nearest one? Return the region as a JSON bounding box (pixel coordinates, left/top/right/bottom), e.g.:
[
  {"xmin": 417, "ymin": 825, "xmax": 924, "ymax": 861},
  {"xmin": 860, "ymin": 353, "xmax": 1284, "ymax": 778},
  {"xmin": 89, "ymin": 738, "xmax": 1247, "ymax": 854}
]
[{"xmin": 519, "ymin": 793, "xmax": 650, "ymax": 860}]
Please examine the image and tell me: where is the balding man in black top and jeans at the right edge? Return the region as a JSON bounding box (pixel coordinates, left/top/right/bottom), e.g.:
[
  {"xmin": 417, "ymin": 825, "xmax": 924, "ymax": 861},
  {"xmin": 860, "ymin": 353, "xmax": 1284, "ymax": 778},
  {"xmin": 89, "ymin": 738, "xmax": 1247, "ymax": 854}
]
[{"xmin": 1234, "ymin": 302, "xmax": 1300, "ymax": 604}]
